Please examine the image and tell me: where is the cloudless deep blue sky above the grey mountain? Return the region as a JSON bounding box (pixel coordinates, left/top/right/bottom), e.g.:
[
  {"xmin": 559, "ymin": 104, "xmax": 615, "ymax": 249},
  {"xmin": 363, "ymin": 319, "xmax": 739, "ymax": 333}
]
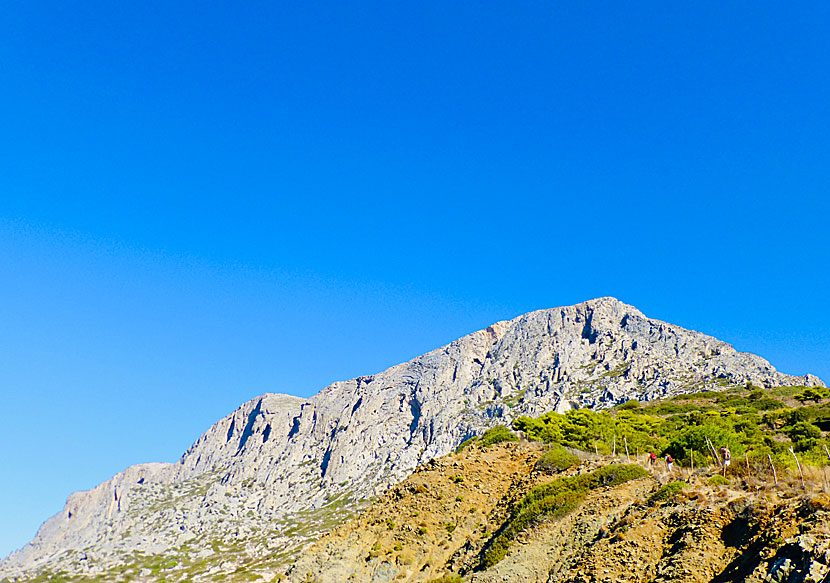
[{"xmin": 0, "ymin": 0, "xmax": 830, "ymax": 555}]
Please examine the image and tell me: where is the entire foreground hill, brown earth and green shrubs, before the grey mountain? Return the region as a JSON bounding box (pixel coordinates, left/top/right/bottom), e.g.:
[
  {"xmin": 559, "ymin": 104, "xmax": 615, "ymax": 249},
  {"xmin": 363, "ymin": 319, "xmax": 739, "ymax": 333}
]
[{"xmin": 285, "ymin": 386, "xmax": 830, "ymax": 583}]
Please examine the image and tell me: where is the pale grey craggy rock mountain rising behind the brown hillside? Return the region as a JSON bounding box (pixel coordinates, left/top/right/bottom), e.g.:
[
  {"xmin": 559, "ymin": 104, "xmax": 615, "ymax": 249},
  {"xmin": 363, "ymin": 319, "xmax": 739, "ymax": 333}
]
[{"xmin": 0, "ymin": 298, "xmax": 823, "ymax": 577}]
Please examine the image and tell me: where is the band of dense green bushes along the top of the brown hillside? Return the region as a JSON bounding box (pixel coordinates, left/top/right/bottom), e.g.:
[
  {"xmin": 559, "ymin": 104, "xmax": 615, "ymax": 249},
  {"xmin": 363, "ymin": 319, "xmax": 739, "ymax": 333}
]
[{"xmin": 513, "ymin": 385, "xmax": 830, "ymax": 473}]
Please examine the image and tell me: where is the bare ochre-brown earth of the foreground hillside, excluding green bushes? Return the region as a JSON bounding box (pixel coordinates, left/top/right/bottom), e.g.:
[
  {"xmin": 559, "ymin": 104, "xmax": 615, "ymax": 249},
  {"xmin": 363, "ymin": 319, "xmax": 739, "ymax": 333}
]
[{"xmin": 287, "ymin": 387, "xmax": 830, "ymax": 583}]
